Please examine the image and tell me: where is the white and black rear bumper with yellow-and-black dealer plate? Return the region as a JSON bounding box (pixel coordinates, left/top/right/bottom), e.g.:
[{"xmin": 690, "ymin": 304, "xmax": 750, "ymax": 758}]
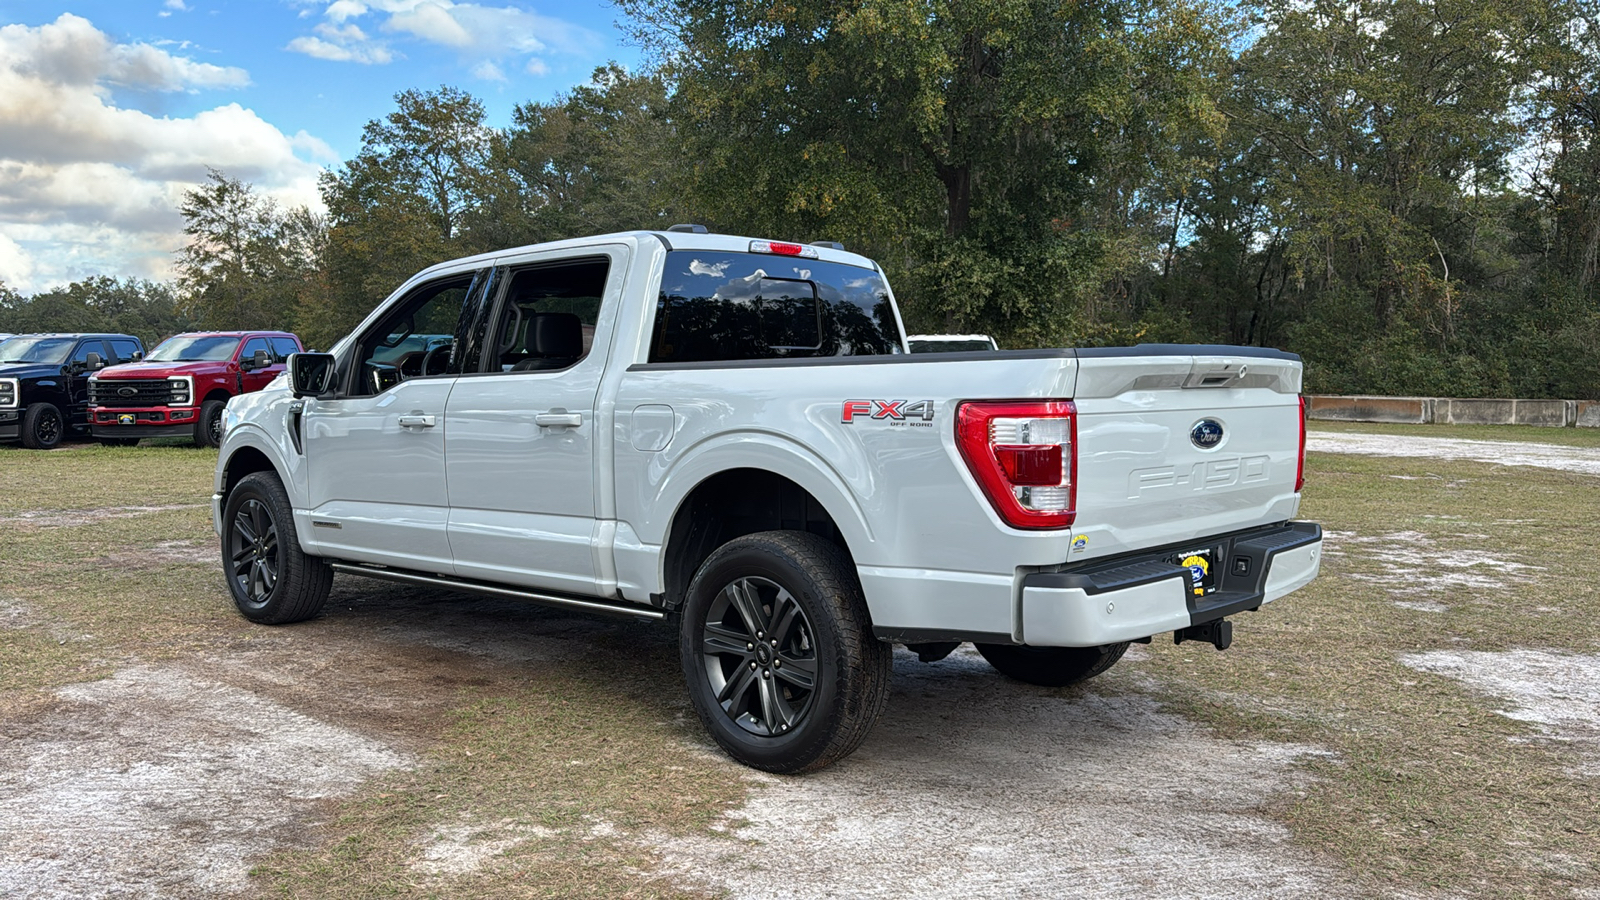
[{"xmin": 1021, "ymin": 522, "xmax": 1322, "ymax": 647}]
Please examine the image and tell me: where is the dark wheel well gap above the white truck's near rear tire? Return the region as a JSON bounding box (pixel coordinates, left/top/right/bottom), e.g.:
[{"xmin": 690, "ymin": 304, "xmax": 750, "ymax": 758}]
[{"xmin": 662, "ymin": 469, "xmax": 853, "ymax": 609}]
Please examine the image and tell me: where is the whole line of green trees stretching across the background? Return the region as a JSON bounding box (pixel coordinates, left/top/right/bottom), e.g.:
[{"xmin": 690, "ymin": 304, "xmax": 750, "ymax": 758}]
[{"xmin": 0, "ymin": 0, "xmax": 1600, "ymax": 399}]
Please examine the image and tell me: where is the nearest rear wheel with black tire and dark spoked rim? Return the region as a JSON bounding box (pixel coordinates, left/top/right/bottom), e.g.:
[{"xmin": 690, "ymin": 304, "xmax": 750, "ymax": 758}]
[{"xmin": 678, "ymin": 532, "xmax": 893, "ymax": 773}]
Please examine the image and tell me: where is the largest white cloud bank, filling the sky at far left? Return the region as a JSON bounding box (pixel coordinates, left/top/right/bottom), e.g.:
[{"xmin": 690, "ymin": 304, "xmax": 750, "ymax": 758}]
[{"xmin": 0, "ymin": 14, "xmax": 336, "ymax": 293}]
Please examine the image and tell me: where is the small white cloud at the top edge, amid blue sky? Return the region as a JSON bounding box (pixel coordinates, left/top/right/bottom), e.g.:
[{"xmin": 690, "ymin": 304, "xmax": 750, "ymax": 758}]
[{"xmin": 288, "ymin": 0, "xmax": 602, "ymax": 77}]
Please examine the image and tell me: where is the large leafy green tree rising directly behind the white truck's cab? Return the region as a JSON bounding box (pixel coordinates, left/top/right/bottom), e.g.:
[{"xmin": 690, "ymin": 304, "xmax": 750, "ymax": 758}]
[{"xmin": 622, "ymin": 0, "xmax": 1227, "ymax": 344}]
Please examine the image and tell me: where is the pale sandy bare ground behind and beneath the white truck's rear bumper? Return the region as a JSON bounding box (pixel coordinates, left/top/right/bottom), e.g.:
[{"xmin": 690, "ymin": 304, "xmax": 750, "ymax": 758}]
[{"xmin": 653, "ymin": 649, "xmax": 1355, "ymax": 900}]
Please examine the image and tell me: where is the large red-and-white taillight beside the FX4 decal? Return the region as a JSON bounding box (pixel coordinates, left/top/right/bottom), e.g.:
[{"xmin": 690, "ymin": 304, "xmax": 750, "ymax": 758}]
[{"xmin": 955, "ymin": 400, "xmax": 1078, "ymax": 528}]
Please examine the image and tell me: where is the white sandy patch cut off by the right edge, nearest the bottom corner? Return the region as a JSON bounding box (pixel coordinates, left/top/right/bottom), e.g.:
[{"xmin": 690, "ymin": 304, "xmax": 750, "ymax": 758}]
[{"xmin": 1400, "ymin": 650, "xmax": 1600, "ymax": 775}]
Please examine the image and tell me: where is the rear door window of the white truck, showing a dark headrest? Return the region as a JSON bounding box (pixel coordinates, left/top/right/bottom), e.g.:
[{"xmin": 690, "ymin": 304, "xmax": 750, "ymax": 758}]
[{"xmin": 486, "ymin": 256, "xmax": 611, "ymax": 372}]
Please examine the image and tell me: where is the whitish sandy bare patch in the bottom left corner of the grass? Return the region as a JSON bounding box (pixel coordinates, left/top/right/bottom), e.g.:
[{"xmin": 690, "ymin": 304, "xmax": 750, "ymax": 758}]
[{"xmin": 0, "ymin": 669, "xmax": 408, "ymax": 900}]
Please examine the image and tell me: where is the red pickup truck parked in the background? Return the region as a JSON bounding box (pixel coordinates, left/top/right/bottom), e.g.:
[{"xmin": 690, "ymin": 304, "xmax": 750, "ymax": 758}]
[{"xmin": 90, "ymin": 331, "xmax": 304, "ymax": 447}]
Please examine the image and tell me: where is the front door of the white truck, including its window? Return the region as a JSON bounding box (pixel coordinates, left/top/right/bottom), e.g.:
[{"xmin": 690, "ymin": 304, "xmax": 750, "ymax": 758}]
[{"xmin": 301, "ymin": 272, "xmax": 482, "ymax": 575}]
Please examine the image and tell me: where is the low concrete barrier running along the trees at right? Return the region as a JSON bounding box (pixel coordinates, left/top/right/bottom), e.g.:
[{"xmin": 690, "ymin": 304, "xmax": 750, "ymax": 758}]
[{"xmin": 1306, "ymin": 394, "xmax": 1600, "ymax": 428}]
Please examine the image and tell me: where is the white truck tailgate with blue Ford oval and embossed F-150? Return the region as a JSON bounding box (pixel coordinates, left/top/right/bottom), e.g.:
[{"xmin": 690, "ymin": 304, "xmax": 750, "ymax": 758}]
[{"xmin": 1070, "ymin": 346, "xmax": 1301, "ymax": 562}]
